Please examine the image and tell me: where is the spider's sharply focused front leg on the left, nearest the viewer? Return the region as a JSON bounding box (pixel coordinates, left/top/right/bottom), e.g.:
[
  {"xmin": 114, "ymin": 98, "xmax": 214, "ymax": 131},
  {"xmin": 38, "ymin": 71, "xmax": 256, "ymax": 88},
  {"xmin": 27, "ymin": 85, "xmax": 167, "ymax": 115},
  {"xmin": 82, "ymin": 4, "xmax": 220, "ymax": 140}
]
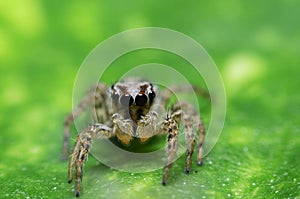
[{"xmin": 68, "ymin": 124, "xmax": 113, "ymax": 197}]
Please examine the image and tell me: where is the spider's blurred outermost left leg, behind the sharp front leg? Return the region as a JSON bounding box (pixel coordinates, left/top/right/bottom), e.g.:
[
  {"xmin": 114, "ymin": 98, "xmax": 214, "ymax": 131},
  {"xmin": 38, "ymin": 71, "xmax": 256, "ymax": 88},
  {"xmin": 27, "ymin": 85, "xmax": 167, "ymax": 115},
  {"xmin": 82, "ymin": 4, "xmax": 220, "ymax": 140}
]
[{"xmin": 61, "ymin": 84, "xmax": 108, "ymax": 160}]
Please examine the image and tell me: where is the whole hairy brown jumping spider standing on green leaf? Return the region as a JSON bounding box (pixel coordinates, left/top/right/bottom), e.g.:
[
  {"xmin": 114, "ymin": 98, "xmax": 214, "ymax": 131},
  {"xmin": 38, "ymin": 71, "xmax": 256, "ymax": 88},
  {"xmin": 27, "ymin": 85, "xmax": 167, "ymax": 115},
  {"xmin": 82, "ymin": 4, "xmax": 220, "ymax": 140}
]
[{"xmin": 62, "ymin": 79, "xmax": 205, "ymax": 197}]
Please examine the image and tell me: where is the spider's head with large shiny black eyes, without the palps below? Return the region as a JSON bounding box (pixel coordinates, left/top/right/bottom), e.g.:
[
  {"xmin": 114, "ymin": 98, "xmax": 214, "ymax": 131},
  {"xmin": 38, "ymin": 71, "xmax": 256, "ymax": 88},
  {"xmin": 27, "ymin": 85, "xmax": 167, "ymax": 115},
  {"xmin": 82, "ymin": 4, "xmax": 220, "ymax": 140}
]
[{"xmin": 110, "ymin": 79, "xmax": 156, "ymax": 122}]
